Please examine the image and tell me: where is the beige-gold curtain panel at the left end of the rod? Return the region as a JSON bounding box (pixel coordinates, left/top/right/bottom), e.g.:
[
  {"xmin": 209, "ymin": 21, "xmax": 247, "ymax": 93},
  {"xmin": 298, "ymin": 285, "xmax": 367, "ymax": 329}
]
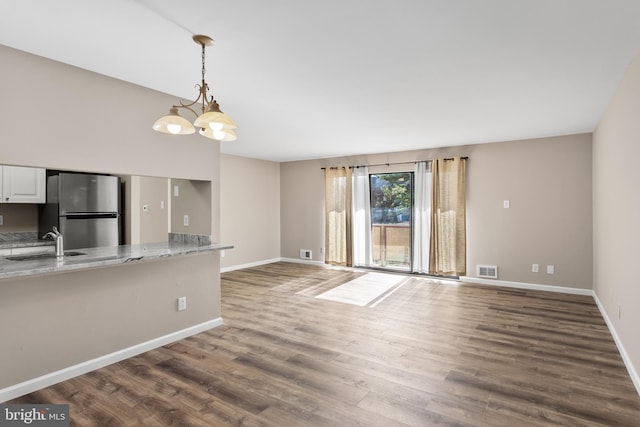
[{"xmin": 324, "ymin": 167, "xmax": 353, "ymax": 267}]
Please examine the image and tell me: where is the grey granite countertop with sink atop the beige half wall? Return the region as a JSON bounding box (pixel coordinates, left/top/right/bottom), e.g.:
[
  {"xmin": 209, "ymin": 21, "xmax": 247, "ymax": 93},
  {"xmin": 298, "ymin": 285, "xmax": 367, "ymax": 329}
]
[{"xmin": 0, "ymin": 243, "xmax": 233, "ymax": 279}]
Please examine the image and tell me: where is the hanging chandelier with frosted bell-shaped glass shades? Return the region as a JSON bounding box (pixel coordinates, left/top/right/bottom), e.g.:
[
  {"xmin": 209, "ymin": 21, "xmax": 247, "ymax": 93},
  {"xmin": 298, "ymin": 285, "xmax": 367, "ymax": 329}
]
[{"xmin": 153, "ymin": 35, "xmax": 237, "ymax": 141}]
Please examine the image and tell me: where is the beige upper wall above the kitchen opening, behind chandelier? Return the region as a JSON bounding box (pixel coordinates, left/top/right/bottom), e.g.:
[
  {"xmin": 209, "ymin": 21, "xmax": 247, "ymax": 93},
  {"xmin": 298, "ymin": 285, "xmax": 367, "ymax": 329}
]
[{"xmin": 0, "ymin": 45, "xmax": 219, "ymax": 180}]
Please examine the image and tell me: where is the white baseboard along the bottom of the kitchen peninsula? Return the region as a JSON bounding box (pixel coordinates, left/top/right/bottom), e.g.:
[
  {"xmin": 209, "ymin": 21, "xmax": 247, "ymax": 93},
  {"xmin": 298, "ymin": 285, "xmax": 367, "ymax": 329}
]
[{"xmin": 0, "ymin": 317, "xmax": 222, "ymax": 403}]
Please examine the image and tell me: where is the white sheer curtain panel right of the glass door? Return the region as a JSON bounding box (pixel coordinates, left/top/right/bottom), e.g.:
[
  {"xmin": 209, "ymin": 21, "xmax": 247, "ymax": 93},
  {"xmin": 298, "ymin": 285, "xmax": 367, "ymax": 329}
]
[{"xmin": 412, "ymin": 162, "xmax": 432, "ymax": 273}]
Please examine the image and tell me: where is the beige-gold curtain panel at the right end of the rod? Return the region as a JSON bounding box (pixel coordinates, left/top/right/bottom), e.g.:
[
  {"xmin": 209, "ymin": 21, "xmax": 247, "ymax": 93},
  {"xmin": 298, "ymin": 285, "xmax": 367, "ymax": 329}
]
[{"xmin": 429, "ymin": 157, "xmax": 467, "ymax": 276}]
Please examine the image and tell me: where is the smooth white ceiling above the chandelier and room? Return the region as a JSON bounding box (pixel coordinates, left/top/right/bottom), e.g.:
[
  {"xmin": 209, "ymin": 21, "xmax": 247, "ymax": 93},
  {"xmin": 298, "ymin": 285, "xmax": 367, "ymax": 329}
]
[{"xmin": 0, "ymin": 0, "xmax": 640, "ymax": 161}]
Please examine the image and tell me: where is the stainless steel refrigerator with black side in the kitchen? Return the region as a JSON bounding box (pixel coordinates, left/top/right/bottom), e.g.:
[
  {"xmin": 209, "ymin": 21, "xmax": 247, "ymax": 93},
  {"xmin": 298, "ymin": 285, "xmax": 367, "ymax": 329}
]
[{"xmin": 39, "ymin": 172, "xmax": 121, "ymax": 249}]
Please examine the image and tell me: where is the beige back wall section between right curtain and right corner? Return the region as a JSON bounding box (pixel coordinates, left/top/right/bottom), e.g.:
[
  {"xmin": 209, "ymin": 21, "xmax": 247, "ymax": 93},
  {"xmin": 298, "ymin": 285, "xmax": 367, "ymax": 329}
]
[{"xmin": 467, "ymin": 134, "xmax": 593, "ymax": 289}]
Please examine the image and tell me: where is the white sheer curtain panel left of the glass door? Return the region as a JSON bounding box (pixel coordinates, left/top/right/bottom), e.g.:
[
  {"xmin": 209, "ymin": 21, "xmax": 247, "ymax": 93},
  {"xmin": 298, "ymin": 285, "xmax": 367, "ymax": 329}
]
[{"xmin": 353, "ymin": 166, "xmax": 372, "ymax": 266}]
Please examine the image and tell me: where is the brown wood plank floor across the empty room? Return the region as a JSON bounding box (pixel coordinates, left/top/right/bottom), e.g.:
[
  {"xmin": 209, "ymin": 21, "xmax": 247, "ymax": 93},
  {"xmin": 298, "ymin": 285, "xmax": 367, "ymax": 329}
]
[{"xmin": 13, "ymin": 263, "xmax": 640, "ymax": 427}]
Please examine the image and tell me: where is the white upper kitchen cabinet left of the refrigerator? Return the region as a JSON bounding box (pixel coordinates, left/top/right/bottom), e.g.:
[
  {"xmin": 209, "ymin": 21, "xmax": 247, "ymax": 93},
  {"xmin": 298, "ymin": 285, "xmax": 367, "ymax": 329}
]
[{"xmin": 2, "ymin": 166, "xmax": 46, "ymax": 203}]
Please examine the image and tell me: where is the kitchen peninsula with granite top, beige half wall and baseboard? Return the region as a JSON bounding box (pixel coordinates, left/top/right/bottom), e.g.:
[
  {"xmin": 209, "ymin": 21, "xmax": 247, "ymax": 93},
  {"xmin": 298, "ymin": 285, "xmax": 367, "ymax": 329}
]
[{"xmin": 0, "ymin": 235, "xmax": 232, "ymax": 402}]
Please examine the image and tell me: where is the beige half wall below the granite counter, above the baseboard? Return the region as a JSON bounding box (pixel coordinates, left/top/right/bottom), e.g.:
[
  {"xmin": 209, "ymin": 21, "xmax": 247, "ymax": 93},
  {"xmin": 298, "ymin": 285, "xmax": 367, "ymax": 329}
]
[{"xmin": 0, "ymin": 254, "xmax": 220, "ymax": 389}]
